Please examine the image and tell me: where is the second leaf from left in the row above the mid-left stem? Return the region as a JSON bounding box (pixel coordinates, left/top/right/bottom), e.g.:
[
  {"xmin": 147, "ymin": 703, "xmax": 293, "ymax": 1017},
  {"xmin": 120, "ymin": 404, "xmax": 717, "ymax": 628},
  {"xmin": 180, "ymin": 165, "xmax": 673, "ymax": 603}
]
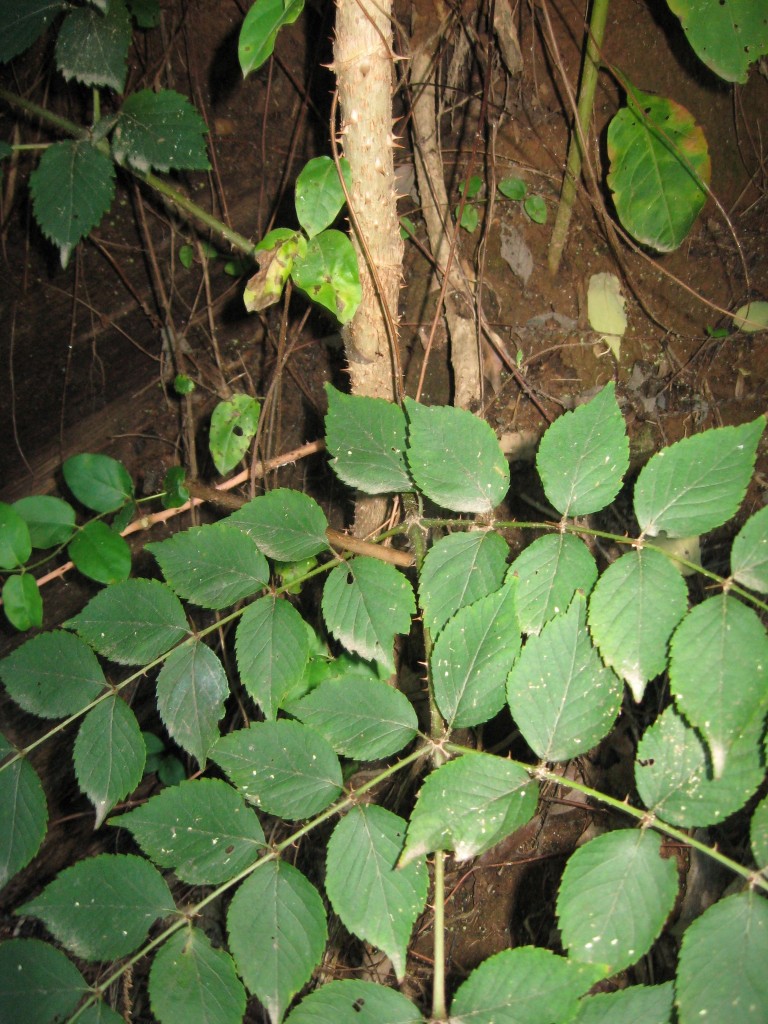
[{"xmin": 65, "ymin": 580, "xmax": 189, "ymax": 665}]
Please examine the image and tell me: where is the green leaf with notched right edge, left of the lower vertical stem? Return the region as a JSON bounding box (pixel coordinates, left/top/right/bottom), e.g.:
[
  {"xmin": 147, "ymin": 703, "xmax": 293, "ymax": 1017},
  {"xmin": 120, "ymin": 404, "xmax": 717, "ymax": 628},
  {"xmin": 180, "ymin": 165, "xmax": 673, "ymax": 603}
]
[{"xmin": 326, "ymin": 806, "xmax": 429, "ymax": 981}]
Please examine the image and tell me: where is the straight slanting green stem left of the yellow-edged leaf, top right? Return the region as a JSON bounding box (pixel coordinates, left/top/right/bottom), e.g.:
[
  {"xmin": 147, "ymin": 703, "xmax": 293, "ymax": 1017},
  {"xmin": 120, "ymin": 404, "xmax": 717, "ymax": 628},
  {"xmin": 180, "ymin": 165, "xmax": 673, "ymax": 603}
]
[{"xmin": 548, "ymin": 0, "xmax": 609, "ymax": 274}]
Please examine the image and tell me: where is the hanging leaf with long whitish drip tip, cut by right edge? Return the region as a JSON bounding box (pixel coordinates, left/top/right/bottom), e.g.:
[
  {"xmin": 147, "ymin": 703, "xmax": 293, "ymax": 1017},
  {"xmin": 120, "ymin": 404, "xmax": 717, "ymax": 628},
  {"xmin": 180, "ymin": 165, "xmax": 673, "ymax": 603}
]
[{"xmin": 670, "ymin": 594, "xmax": 768, "ymax": 778}]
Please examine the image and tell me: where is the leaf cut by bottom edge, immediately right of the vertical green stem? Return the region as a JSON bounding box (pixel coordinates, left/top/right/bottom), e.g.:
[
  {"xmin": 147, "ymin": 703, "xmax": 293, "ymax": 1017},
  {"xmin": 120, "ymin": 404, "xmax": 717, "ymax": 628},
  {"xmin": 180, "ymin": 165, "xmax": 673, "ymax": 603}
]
[{"xmin": 451, "ymin": 946, "xmax": 606, "ymax": 1024}]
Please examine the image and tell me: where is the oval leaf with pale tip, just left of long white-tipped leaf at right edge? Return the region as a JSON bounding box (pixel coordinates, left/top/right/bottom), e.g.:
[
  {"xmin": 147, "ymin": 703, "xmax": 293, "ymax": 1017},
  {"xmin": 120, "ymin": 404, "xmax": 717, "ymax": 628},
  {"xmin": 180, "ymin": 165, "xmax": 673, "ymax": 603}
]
[{"xmin": 589, "ymin": 549, "xmax": 688, "ymax": 701}]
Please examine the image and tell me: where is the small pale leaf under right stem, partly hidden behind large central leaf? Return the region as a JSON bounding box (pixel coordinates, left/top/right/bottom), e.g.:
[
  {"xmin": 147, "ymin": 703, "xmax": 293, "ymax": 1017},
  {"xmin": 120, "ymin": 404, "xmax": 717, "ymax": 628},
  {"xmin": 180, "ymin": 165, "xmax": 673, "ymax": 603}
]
[{"xmin": 507, "ymin": 534, "xmax": 597, "ymax": 635}]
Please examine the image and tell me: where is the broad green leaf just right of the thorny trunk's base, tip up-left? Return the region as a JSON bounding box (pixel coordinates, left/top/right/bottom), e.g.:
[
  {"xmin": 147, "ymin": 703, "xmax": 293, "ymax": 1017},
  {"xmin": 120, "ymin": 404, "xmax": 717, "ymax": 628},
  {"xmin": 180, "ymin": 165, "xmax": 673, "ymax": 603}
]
[{"xmin": 403, "ymin": 398, "xmax": 509, "ymax": 514}]
